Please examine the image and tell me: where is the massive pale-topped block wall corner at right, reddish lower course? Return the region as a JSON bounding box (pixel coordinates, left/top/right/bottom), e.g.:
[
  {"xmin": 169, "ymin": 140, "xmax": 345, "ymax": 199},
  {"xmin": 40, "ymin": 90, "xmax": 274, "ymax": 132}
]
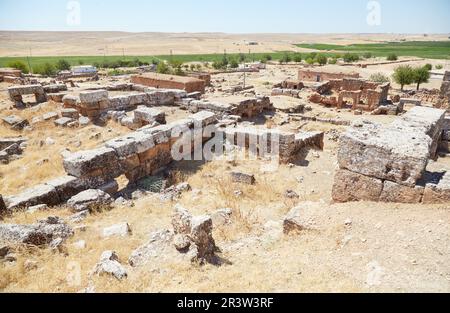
[{"xmin": 332, "ymin": 107, "xmax": 450, "ymax": 203}]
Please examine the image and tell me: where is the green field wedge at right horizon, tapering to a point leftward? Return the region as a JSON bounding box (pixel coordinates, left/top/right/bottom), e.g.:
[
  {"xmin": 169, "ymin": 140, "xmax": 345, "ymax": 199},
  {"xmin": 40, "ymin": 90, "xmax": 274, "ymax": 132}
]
[{"xmin": 296, "ymin": 41, "xmax": 450, "ymax": 59}]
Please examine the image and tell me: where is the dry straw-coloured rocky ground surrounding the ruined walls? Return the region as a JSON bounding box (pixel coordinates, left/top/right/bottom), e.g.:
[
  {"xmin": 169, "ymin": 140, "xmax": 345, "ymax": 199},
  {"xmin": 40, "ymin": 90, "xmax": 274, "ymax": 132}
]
[{"xmin": 0, "ymin": 62, "xmax": 450, "ymax": 292}]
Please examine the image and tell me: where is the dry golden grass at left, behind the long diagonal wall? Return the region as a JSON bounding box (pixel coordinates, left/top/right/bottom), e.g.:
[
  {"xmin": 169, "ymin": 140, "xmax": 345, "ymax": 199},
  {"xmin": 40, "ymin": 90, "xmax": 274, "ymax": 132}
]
[{"xmin": 0, "ymin": 102, "xmax": 129, "ymax": 195}]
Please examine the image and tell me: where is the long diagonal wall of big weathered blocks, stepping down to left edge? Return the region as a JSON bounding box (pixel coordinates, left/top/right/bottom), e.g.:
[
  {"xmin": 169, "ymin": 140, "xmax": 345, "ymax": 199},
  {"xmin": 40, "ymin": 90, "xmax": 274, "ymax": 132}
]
[{"xmin": 4, "ymin": 111, "xmax": 216, "ymax": 210}]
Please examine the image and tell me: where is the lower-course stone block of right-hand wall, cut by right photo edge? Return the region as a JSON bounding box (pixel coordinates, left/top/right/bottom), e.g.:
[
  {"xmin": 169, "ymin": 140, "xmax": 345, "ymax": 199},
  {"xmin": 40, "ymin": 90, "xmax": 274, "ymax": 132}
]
[{"xmin": 422, "ymin": 172, "xmax": 450, "ymax": 204}]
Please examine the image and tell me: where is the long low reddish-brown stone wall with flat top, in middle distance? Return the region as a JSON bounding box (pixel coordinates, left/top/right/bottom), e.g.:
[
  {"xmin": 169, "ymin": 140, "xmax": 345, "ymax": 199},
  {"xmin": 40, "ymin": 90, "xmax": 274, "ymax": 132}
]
[{"xmin": 131, "ymin": 73, "xmax": 206, "ymax": 93}]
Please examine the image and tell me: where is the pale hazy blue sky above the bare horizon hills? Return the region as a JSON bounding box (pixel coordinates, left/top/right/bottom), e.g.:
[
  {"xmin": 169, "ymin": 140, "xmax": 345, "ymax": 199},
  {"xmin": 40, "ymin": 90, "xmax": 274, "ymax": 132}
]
[{"xmin": 0, "ymin": 0, "xmax": 450, "ymax": 33}]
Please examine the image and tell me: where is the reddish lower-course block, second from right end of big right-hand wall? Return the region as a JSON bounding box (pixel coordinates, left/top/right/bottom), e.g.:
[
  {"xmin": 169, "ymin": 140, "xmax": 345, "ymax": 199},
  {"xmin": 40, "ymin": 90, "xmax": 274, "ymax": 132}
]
[{"xmin": 380, "ymin": 180, "xmax": 424, "ymax": 203}]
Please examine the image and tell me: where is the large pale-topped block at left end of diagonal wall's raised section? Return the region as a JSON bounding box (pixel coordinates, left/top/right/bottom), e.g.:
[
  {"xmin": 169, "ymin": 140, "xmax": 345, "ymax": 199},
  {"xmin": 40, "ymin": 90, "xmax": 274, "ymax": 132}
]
[{"xmin": 63, "ymin": 147, "xmax": 119, "ymax": 177}]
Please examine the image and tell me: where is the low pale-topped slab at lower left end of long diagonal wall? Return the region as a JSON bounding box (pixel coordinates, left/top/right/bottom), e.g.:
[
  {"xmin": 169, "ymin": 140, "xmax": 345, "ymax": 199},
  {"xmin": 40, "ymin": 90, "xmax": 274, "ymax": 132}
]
[{"xmin": 8, "ymin": 185, "xmax": 61, "ymax": 210}]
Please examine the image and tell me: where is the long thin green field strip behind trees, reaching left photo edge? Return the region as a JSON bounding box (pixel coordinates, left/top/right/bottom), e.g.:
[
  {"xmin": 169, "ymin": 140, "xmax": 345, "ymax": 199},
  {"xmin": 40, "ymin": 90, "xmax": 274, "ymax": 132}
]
[{"xmin": 0, "ymin": 52, "xmax": 298, "ymax": 67}]
